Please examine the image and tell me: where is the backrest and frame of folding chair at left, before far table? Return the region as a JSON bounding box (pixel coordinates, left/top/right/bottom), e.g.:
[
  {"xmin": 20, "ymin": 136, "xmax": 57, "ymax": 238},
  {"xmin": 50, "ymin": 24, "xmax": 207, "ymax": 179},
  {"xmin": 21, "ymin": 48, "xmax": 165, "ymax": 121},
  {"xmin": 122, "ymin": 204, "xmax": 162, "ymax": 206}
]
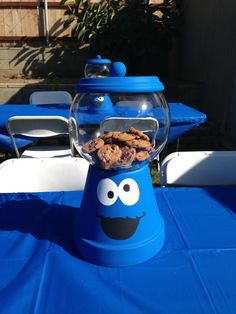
[{"xmin": 7, "ymin": 116, "xmax": 69, "ymax": 157}]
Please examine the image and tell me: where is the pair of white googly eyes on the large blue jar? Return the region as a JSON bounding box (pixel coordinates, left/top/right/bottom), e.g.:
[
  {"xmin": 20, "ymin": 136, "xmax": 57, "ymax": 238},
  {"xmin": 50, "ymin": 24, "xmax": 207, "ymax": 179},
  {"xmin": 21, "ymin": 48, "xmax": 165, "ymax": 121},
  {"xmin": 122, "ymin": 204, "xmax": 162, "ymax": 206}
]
[{"xmin": 97, "ymin": 178, "xmax": 140, "ymax": 206}]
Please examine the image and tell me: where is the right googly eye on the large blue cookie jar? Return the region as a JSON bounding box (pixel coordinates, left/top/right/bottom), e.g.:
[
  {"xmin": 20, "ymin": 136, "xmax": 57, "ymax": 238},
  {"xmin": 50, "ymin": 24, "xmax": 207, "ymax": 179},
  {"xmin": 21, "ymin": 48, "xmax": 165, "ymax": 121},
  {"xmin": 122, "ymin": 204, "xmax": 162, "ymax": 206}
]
[{"xmin": 119, "ymin": 178, "xmax": 140, "ymax": 206}]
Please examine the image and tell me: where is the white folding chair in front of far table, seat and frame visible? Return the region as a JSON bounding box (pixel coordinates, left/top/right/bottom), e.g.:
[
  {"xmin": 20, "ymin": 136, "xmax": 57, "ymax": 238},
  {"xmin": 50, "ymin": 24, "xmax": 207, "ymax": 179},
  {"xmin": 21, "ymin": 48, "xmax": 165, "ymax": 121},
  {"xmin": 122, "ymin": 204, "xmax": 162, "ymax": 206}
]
[{"xmin": 7, "ymin": 116, "xmax": 73, "ymax": 158}]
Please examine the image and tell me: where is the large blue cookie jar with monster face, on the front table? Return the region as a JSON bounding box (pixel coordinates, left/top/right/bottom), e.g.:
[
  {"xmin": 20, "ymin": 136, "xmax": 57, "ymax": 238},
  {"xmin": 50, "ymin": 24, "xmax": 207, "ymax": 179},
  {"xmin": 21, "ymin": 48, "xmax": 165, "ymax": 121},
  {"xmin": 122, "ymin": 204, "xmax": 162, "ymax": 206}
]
[{"xmin": 69, "ymin": 63, "xmax": 170, "ymax": 267}]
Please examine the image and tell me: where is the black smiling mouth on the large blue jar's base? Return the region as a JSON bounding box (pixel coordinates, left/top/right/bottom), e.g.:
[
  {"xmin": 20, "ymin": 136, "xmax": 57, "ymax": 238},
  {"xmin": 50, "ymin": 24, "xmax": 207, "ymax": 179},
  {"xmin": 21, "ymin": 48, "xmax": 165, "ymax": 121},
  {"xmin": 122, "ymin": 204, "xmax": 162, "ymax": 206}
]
[{"xmin": 97, "ymin": 212, "xmax": 145, "ymax": 240}]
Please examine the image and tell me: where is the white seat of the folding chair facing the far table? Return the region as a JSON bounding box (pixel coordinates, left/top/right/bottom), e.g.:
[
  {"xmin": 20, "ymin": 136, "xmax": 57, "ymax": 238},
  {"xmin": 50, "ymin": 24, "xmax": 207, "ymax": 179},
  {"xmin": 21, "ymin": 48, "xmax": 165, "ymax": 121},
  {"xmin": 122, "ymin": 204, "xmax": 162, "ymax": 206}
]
[{"xmin": 21, "ymin": 146, "xmax": 71, "ymax": 158}]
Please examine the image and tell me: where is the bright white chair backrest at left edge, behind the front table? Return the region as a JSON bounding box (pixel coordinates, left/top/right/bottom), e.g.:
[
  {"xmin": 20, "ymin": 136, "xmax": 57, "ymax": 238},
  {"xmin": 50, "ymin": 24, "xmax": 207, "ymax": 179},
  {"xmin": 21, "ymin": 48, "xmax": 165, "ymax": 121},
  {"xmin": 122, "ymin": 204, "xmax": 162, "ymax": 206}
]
[{"xmin": 0, "ymin": 157, "xmax": 89, "ymax": 193}]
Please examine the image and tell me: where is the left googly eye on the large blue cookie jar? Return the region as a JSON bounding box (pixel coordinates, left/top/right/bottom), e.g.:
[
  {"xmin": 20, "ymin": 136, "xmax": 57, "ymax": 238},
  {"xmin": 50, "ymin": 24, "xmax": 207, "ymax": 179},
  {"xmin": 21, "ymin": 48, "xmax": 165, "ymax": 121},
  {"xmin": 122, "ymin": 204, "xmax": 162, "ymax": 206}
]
[{"xmin": 97, "ymin": 179, "xmax": 118, "ymax": 206}]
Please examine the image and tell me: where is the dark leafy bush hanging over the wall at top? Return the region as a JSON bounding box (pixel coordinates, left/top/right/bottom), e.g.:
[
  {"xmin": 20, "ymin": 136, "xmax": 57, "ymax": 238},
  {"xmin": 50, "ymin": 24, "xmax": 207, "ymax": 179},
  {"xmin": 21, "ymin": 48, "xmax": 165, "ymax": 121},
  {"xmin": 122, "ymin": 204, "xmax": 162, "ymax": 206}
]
[{"xmin": 61, "ymin": 0, "xmax": 181, "ymax": 75}]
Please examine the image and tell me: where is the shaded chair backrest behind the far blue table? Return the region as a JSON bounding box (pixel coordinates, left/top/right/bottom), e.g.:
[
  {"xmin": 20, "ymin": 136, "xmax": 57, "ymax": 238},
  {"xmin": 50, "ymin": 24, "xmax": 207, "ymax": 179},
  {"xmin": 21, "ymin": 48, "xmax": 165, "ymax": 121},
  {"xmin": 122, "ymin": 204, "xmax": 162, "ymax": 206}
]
[{"xmin": 29, "ymin": 91, "xmax": 72, "ymax": 105}]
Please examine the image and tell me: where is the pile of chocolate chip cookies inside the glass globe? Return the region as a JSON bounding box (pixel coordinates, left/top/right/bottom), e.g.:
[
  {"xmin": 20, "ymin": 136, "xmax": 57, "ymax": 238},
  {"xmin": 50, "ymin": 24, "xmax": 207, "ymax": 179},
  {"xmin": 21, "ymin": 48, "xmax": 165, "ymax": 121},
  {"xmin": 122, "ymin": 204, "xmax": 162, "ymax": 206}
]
[{"xmin": 82, "ymin": 127, "xmax": 155, "ymax": 170}]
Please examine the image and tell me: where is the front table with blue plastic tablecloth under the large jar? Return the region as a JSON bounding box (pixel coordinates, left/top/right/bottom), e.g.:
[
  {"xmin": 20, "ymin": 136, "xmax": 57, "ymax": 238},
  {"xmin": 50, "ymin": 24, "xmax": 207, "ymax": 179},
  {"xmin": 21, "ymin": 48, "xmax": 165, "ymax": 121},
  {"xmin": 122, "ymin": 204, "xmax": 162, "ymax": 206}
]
[{"xmin": 0, "ymin": 187, "xmax": 236, "ymax": 314}]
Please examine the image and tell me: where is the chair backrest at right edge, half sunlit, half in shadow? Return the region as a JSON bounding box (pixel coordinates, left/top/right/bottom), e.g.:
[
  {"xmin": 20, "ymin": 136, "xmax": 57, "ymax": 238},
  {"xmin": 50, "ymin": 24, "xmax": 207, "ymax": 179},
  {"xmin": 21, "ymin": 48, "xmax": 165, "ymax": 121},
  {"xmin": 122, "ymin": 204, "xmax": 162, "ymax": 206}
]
[{"xmin": 160, "ymin": 151, "xmax": 236, "ymax": 186}]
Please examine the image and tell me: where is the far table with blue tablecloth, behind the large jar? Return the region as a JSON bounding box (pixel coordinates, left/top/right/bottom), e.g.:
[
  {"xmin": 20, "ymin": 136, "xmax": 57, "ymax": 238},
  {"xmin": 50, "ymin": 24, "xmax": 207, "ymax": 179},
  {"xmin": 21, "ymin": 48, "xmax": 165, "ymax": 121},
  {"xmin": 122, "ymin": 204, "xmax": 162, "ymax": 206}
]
[{"xmin": 0, "ymin": 103, "xmax": 206, "ymax": 151}]
